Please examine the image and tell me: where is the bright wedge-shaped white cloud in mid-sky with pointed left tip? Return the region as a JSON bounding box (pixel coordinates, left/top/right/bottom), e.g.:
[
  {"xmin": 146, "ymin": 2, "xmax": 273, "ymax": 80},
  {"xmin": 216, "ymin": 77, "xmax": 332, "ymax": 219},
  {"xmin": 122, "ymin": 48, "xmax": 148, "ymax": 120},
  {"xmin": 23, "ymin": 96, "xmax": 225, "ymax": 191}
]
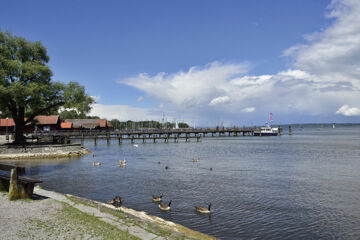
[{"xmin": 119, "ymin": 62, "xmax": 247, "ymax": 108}]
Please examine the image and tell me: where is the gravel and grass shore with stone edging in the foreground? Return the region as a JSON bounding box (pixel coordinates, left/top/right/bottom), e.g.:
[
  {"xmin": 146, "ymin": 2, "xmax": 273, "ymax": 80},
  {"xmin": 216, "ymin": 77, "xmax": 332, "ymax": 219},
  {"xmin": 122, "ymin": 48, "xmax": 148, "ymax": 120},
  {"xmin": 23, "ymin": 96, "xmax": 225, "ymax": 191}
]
[{"xmin": 0, "ymin": 187, "xmax": 215, "ymax": 240}]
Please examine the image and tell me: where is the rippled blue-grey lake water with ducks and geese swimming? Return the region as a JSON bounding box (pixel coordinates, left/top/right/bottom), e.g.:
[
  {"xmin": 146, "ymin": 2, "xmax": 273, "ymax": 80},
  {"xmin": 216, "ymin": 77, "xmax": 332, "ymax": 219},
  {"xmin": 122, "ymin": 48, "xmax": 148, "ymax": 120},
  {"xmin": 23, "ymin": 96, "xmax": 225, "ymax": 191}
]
[{"xmin": 7, "ymin": 125, "xmax": 360, "ymax": 239}]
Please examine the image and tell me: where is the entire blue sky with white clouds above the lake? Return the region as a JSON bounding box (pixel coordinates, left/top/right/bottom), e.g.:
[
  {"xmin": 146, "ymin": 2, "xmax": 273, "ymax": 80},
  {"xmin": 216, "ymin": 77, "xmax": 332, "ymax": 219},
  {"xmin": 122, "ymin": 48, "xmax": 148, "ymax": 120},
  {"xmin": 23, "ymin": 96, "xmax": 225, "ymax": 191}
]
[{"xmin": 0, "ymin": 0, "xmax": 360, "ymax": 126}]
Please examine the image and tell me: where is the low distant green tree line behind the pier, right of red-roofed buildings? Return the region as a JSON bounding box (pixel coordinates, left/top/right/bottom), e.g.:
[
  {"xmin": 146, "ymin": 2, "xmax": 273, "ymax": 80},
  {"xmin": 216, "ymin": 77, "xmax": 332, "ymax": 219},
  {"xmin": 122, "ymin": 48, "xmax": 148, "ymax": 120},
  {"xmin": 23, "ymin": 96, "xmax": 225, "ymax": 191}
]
[{"xmin": 110, "ymin": 119, "xmax": 189, "ymax": 129}]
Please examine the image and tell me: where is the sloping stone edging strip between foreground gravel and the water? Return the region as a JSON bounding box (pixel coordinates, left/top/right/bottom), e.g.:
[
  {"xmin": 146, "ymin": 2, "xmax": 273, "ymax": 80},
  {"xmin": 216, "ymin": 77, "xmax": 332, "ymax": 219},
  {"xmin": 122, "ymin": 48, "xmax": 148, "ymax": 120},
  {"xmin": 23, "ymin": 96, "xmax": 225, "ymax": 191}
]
[{"xmin": 34, "ymin": 187, "xmax": 215, "ymax": 240}]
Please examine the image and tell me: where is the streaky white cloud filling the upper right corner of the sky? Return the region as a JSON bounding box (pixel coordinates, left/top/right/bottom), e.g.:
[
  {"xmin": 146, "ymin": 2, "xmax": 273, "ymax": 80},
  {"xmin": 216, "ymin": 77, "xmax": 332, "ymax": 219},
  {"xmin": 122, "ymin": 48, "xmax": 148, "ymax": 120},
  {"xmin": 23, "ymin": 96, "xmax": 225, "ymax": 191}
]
[{"xmin": 284, "ymin": 0, "xmax": 360, "ymax": 90}]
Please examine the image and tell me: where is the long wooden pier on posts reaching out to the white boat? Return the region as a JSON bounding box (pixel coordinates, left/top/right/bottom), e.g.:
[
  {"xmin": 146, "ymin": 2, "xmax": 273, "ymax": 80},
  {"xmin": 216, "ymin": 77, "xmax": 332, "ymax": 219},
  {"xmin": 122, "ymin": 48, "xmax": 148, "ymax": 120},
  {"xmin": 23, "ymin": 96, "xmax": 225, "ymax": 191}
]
[{"xmin": 32, "ymin": 127, "xmax": 281, "ymax": 144}]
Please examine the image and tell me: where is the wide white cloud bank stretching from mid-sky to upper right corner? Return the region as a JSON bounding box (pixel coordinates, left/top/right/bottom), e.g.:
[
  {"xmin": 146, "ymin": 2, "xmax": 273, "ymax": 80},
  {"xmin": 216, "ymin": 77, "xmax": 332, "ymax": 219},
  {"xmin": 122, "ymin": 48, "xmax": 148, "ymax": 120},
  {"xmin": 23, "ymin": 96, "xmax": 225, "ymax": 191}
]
[{"xmin": 114, "ymin": 0, "xmax": 360, "ymax": 122}]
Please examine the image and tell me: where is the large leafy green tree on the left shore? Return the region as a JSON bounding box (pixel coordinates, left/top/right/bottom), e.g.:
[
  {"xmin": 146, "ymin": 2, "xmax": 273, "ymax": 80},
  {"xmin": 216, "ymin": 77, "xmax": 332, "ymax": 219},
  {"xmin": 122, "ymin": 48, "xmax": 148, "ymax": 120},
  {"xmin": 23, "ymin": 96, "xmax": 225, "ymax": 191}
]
[{"xmin": 0, "ymin": 30, "xmax": 94, "ymax": 144}]
